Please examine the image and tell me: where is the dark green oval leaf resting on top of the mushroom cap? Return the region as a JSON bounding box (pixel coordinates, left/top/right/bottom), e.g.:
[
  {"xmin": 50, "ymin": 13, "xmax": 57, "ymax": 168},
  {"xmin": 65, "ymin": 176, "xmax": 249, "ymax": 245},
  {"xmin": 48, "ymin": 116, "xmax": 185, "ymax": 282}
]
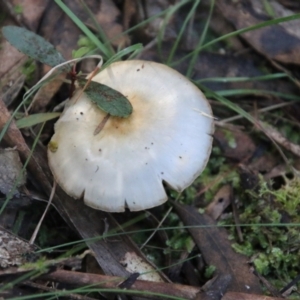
[{"xmin": 79, "ymin": 80, "xmax": 132, "ymax": 118}]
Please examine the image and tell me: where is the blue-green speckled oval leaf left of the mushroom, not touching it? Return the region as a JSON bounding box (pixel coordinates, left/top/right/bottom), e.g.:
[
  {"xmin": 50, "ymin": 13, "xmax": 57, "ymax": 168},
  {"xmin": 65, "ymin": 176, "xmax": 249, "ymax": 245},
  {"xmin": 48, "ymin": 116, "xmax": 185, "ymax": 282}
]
[{"xmin": 2, "ymin": 26, "xmax": 70, "ymax": 71}]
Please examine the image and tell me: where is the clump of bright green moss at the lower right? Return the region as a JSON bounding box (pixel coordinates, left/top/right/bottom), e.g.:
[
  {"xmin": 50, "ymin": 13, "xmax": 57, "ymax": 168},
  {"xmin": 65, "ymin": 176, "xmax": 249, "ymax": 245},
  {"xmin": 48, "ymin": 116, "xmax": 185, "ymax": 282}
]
[{"xmin": 226, "ymin": 178, "xmax": 300, "ymax": 289}]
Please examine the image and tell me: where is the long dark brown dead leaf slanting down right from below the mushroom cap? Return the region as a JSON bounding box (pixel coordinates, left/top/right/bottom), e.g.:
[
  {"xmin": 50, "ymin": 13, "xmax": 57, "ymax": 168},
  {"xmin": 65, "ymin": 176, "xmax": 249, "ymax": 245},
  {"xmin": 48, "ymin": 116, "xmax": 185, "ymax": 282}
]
[{"xmin": 173, "ymin": 203, "xmax": 261, "ymax": 294}]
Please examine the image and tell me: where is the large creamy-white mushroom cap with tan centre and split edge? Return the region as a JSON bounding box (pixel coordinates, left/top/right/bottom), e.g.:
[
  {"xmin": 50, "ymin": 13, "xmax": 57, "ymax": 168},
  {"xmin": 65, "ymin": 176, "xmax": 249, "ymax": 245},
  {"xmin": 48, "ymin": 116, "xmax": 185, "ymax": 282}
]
[{"xmin": 48, "ymin": 61, "xmax": 214, "ymax": 212}]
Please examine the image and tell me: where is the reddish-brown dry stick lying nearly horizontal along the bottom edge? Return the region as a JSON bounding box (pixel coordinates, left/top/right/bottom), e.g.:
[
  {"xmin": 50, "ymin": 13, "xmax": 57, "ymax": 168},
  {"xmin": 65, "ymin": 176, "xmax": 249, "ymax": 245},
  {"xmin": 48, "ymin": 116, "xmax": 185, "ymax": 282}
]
[{"xmin": 41, "ymin": 270, "xmax": 204, "ymax": 300}]
